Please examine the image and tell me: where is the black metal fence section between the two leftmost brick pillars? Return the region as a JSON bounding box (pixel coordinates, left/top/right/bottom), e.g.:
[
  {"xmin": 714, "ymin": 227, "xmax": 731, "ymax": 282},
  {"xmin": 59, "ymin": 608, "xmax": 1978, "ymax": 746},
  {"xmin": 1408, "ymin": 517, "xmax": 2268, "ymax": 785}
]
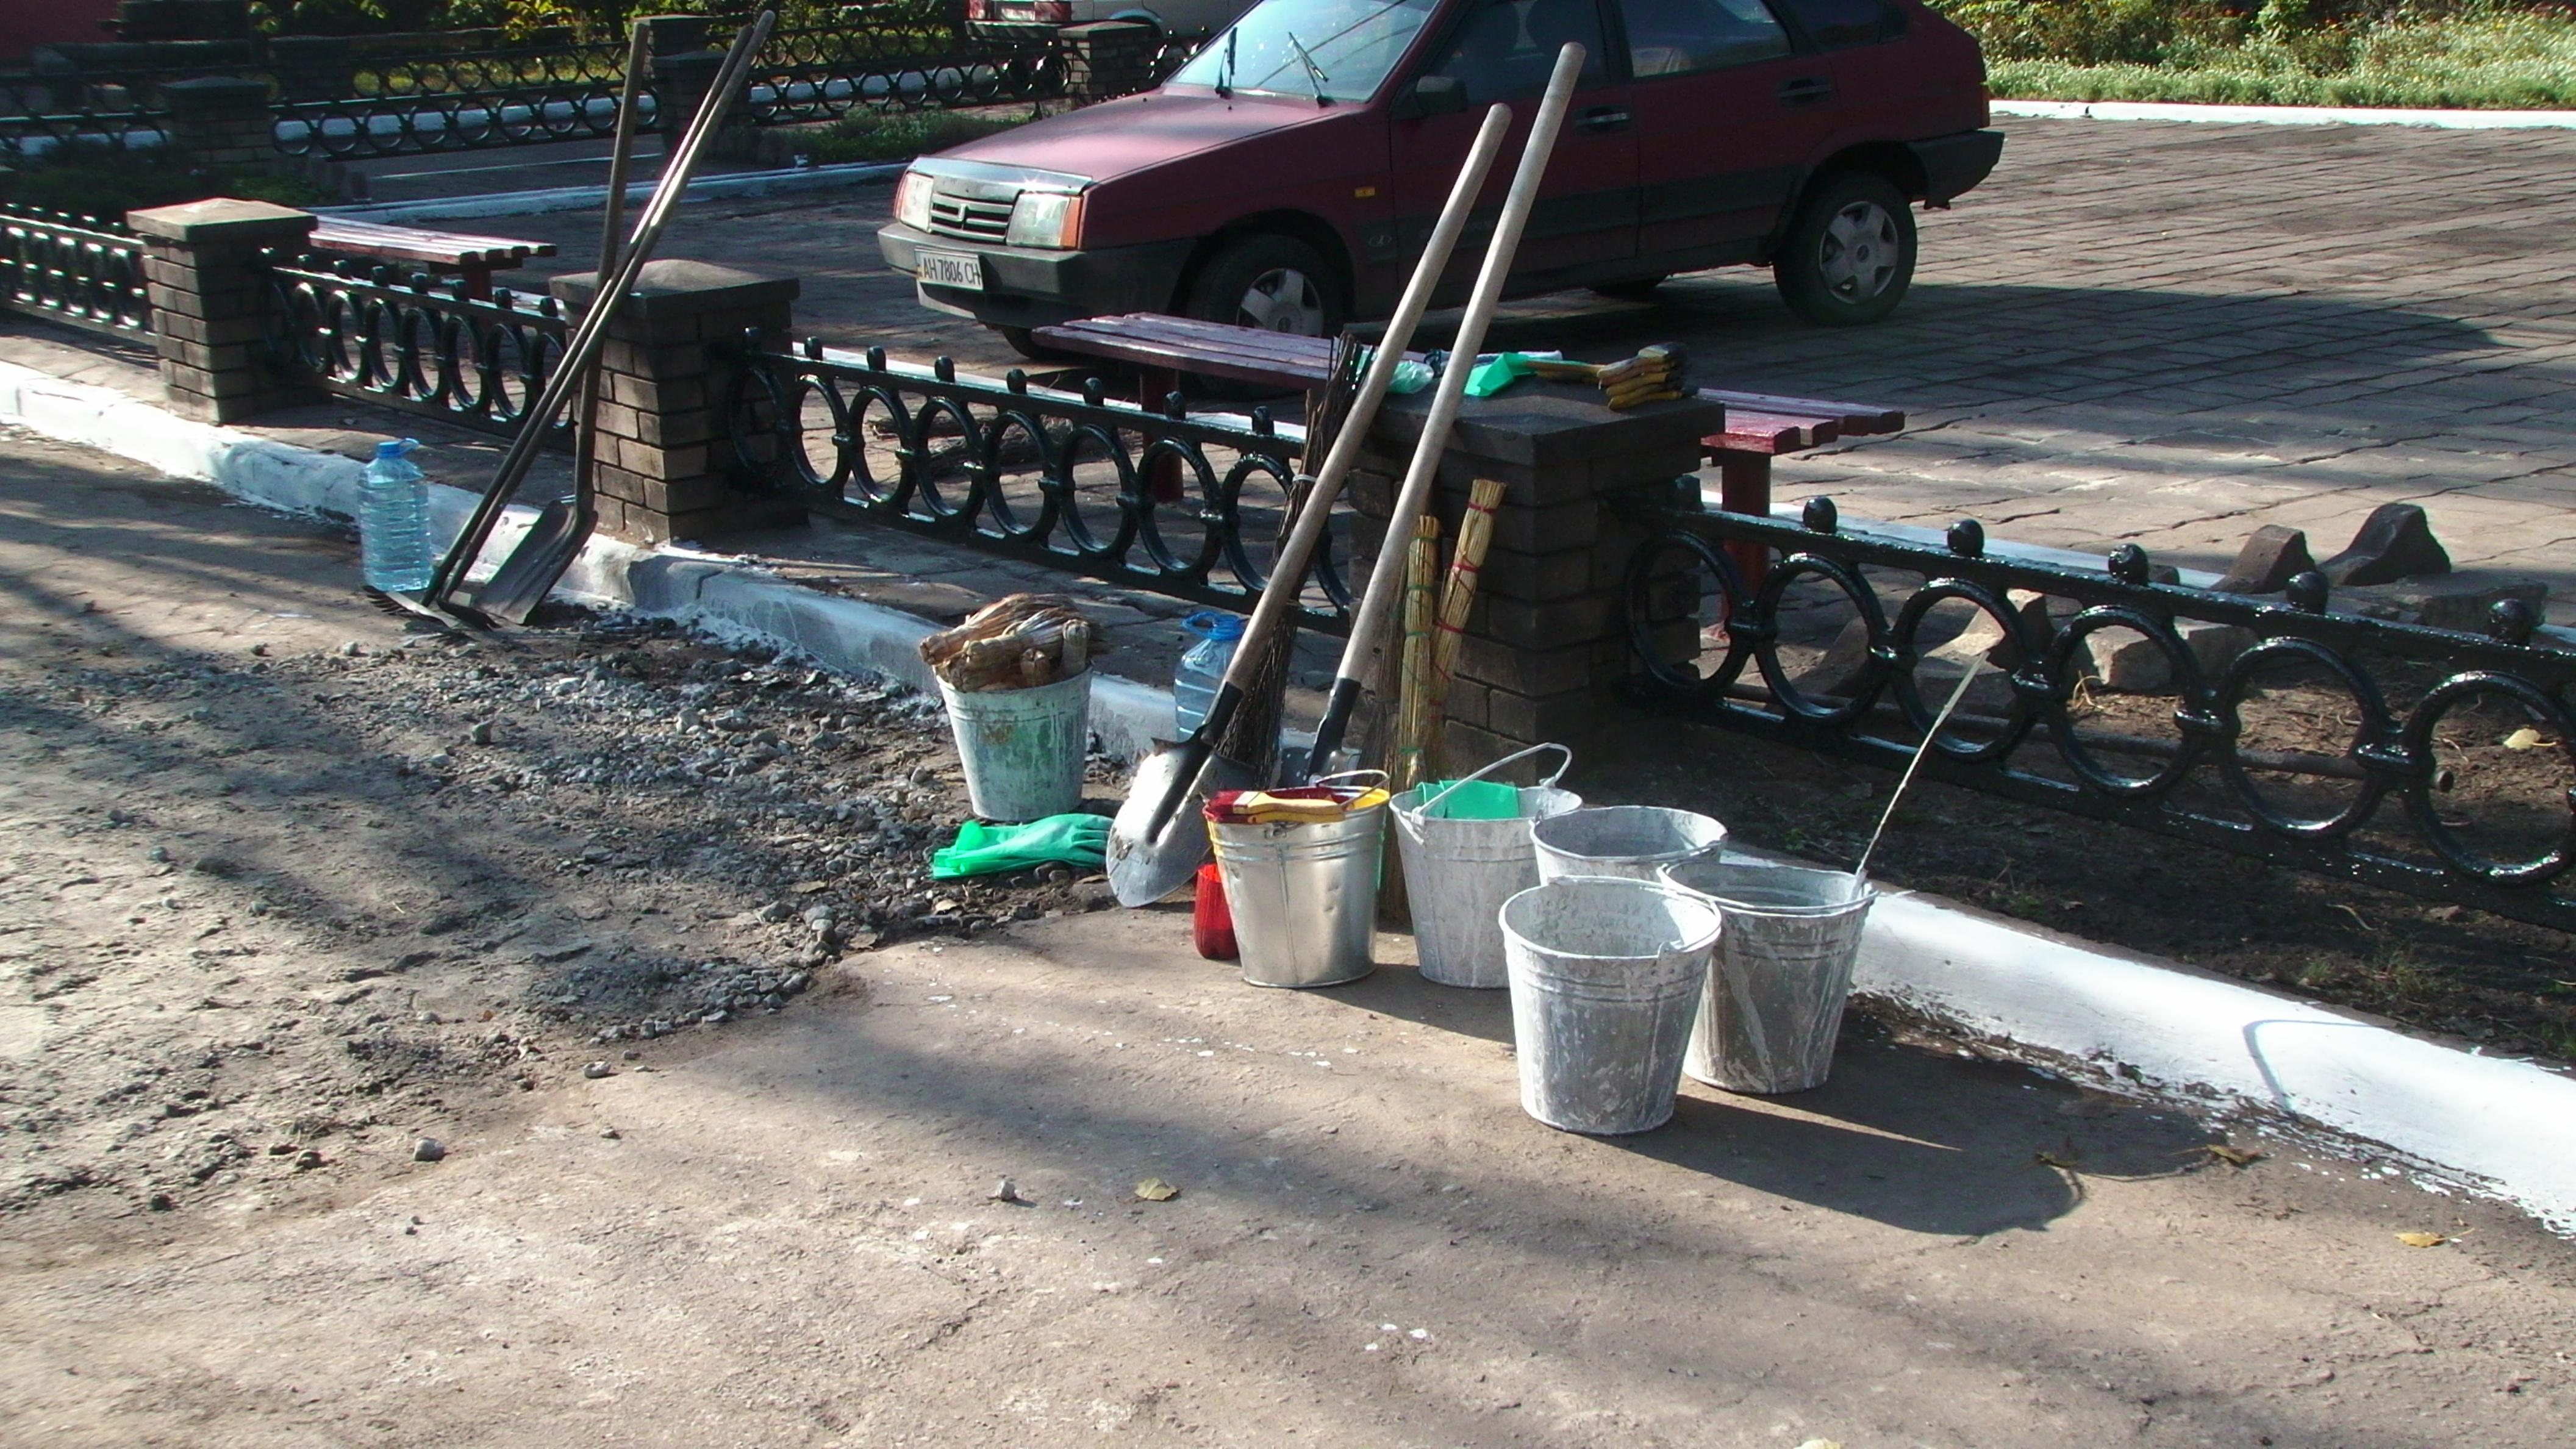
[{"xmin": 268, "ymin": 256, "xmax": 570, "ymax": 433}]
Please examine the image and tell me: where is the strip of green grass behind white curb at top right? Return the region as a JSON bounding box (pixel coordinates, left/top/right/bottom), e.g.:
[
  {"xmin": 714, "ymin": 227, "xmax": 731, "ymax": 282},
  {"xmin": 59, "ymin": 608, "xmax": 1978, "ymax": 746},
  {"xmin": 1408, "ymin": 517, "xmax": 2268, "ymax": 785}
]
[{"xmin": 1945, "ymin": 0, "xmax": 2576, "ymax": 111}]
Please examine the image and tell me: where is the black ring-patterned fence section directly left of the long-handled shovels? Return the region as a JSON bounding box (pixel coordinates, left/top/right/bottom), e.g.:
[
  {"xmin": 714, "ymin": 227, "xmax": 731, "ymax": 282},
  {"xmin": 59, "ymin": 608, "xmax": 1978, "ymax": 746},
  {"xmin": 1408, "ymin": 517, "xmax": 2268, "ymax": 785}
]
[{"xmin": 726, "ymin": 343, "xmax": 1350, "ymax": 634}]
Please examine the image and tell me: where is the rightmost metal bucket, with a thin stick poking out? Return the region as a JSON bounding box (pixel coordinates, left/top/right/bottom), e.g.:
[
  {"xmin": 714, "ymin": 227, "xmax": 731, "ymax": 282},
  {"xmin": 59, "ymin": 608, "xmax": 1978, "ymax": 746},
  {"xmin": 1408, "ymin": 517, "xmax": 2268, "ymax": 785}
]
[{"xmin": 1664, "ymin": 856, "xmax": 1878, "ymax": 1093}]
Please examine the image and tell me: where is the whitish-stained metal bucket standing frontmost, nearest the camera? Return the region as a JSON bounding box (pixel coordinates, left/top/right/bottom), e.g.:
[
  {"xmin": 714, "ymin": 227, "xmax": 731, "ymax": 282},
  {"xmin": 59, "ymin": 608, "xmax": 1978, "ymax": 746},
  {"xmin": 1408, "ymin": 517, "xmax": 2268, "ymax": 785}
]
[{"xmin": 1502, "ymin": 876, "xmax": 1718, "ymax": 1134}]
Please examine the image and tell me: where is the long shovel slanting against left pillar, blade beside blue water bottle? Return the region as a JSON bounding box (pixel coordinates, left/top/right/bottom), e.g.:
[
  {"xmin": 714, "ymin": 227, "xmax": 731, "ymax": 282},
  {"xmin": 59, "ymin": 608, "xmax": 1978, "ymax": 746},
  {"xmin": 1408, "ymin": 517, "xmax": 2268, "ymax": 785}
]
[{"xmin": 423, "ymin": 10, "xmax": 778, "ymax": 624}]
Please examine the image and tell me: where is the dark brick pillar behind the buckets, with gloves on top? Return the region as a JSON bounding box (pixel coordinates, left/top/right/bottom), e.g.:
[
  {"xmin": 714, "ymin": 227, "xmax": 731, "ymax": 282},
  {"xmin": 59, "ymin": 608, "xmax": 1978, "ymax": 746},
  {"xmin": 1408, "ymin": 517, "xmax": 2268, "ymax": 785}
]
[{"xmin": 1347, "ymin": 382, "xmax": 1726, "ymax": 768}]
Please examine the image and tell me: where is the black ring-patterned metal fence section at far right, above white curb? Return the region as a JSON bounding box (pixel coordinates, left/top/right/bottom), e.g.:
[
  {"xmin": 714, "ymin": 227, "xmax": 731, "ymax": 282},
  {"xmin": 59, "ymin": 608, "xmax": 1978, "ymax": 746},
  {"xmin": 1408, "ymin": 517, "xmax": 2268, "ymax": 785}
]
[{"xmin": 1625, "ymin": 500, "xmax": 2576, "ymax": 928}]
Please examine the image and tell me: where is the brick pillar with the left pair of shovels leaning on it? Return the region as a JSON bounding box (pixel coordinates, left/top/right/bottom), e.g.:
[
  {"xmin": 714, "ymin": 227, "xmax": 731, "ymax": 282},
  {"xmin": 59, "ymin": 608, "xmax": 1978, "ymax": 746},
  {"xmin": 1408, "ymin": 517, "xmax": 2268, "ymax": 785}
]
[{"xmin": 549, "ymin": 260, "xmax": 804, "ymax": 544}]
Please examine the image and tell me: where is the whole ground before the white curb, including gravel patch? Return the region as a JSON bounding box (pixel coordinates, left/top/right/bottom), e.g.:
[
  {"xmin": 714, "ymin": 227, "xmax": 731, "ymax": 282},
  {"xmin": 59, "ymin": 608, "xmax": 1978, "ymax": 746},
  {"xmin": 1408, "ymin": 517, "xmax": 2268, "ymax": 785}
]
[{"xmin": 0, "ymin": 435, "xmax": 2576, "ymax": 1449}]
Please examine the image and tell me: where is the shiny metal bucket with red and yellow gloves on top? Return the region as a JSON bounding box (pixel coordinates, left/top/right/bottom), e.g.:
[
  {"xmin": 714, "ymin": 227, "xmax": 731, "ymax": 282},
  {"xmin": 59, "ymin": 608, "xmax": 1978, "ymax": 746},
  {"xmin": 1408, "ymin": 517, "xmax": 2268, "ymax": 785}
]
[{"xmin": 1208, "ymin": 771, "xmax": 1386, "ymax": 987}]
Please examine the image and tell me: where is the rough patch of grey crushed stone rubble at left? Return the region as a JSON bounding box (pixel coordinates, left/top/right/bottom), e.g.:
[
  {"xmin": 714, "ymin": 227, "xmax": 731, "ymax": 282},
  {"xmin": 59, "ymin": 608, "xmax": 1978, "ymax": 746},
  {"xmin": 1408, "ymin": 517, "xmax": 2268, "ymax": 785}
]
[{"xmin": 0, "ymin": 603, "xmax": 1111, "ymax": 1212}]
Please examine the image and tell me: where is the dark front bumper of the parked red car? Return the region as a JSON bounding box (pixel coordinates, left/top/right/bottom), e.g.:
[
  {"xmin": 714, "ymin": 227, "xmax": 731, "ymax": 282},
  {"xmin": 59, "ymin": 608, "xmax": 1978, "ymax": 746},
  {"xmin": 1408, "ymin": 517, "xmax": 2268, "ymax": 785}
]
[{"xmin": 876, "ymin": 222, "xmax": 1193, "ymax": 327}]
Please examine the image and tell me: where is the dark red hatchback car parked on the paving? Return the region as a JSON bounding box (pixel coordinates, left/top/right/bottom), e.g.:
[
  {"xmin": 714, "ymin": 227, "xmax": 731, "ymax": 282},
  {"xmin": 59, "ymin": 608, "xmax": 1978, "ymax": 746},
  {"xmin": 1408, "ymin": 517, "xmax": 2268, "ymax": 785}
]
[{"xmin": 876, "ymin": 0, "xmax": 2004, "ymax": 351}]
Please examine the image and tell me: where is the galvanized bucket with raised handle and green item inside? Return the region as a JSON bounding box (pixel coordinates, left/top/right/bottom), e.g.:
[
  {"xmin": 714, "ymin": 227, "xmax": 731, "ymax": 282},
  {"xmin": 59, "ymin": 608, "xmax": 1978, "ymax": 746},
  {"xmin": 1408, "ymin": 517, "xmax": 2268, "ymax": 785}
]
[{"xmin": 1389, "ymin": 745, "xmax": 1584, "ymax": 990}]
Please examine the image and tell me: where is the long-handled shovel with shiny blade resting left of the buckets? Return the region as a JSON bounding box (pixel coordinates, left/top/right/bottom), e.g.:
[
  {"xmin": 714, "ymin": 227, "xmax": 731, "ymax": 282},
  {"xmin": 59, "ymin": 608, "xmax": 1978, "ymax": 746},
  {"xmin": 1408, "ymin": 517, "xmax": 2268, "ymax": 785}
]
[{"xmin": 1107, "ymin": 106, "xmax": 1512, "ymax": 905}]
